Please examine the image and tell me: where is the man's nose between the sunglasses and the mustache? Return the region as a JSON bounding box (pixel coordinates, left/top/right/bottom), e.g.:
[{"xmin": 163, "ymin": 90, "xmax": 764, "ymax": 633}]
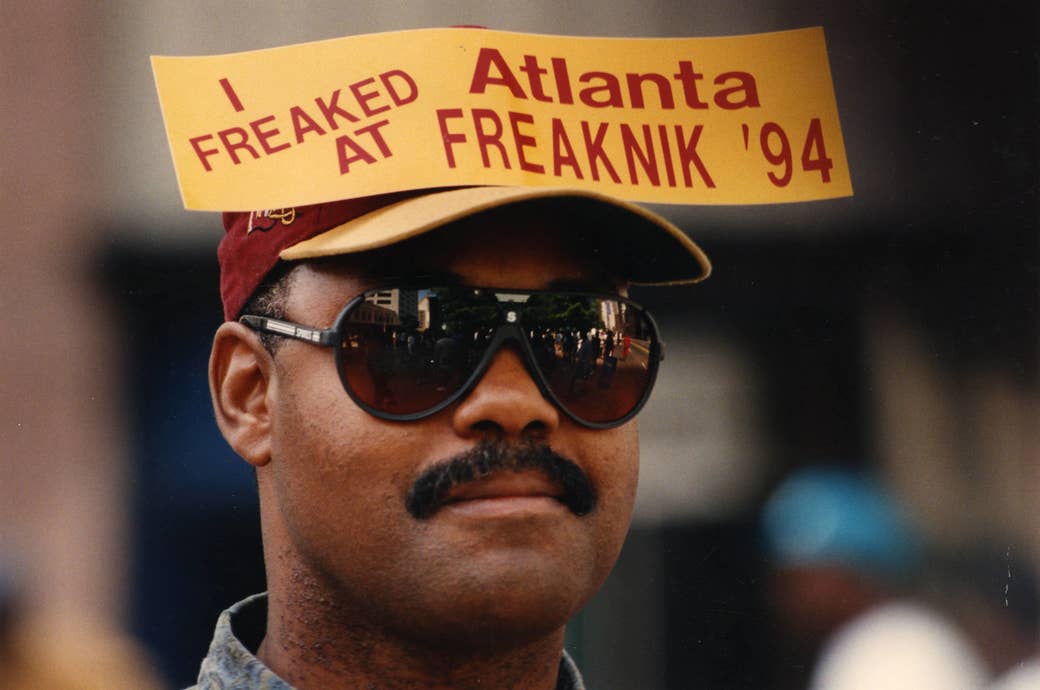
[{"xmin": 452, "ymin": 346, "xmax": 560, "ymax": 439}]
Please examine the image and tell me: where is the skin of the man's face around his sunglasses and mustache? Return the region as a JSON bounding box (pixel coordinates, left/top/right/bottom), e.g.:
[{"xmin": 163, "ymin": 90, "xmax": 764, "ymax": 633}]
[{"xmin": 258, "ymin": 213, "xmax": 638, "ymax": 645}]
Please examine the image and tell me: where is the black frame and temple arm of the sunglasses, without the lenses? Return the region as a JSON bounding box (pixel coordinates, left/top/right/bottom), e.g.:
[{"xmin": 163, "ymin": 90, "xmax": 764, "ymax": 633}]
[{"xmin": 238, "ymin": 284, "xmax": 665, "ymax": 429}]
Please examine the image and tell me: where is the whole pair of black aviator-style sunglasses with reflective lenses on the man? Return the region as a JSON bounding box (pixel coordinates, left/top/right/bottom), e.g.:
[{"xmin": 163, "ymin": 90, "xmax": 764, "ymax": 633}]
[{"xmin": 239, "ymin": 285, "xmax": 664, "ymax": 429}]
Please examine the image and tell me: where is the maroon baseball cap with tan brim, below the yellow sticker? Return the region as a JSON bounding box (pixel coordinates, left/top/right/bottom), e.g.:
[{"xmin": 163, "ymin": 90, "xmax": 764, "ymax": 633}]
[{"xmin": 217, "ymin": 186, "xmax": 711, "ymax": 321}]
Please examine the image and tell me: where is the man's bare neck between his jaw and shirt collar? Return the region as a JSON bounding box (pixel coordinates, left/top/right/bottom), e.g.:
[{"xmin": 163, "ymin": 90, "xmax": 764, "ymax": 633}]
[{"xmin": 257, "ymin": 573, "xmax": 564, "ymax": 690}]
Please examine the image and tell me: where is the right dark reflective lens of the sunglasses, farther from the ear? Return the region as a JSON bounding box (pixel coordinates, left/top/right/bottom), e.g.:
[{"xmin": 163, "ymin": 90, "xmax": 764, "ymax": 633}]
[{"xmin": 524, "ymin": 295, "xmax": 657, "ymax": 424}]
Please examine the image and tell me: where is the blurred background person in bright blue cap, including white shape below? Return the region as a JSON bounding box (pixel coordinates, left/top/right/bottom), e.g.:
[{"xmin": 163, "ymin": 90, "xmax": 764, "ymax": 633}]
[{"xmin": 761, "ymin": 467, "xmax": 989, "ymax": 690}]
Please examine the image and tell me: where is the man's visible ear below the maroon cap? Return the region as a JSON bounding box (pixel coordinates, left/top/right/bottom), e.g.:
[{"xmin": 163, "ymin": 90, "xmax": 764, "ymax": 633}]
[{"xmin": 209, "ymin": 322, "xmax": 275, "ymax": 467}]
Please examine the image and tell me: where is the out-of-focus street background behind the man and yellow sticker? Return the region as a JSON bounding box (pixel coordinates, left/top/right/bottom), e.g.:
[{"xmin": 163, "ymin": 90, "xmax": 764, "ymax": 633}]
[{"xmin": 0, "ymin": 0, "xmax": 1040, "ymax": 690}]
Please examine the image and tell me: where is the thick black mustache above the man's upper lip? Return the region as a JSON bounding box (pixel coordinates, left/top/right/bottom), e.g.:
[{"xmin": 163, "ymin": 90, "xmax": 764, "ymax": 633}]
[{"xmin": 405, "ymin": 441, "xmax": 596, "ymax": 519}]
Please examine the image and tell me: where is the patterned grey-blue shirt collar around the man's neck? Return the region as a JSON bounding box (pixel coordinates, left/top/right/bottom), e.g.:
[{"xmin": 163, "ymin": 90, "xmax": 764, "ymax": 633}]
[{"xmin": 189, "ymin": 594, "xmax": 586, "ymax": 690}]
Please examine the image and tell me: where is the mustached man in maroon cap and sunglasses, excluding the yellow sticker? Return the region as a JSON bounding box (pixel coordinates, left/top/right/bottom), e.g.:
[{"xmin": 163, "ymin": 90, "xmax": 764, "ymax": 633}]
[{"xmin": 199, "ymin": 187, "xmax": 710, "ymax": 690}]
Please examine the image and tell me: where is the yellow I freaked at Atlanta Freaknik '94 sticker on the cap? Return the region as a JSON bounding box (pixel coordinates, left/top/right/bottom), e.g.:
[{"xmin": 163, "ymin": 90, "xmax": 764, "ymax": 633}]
[{"xmin": 152, "ymin": 27, "xmax": 852, "ymax": 211}]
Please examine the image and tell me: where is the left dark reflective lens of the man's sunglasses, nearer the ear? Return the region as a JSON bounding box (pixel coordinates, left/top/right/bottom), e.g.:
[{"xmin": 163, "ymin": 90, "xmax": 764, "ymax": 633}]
[{"xmin": 339, "ymin": 287, "xmax": 497, "ymax": 415}]
